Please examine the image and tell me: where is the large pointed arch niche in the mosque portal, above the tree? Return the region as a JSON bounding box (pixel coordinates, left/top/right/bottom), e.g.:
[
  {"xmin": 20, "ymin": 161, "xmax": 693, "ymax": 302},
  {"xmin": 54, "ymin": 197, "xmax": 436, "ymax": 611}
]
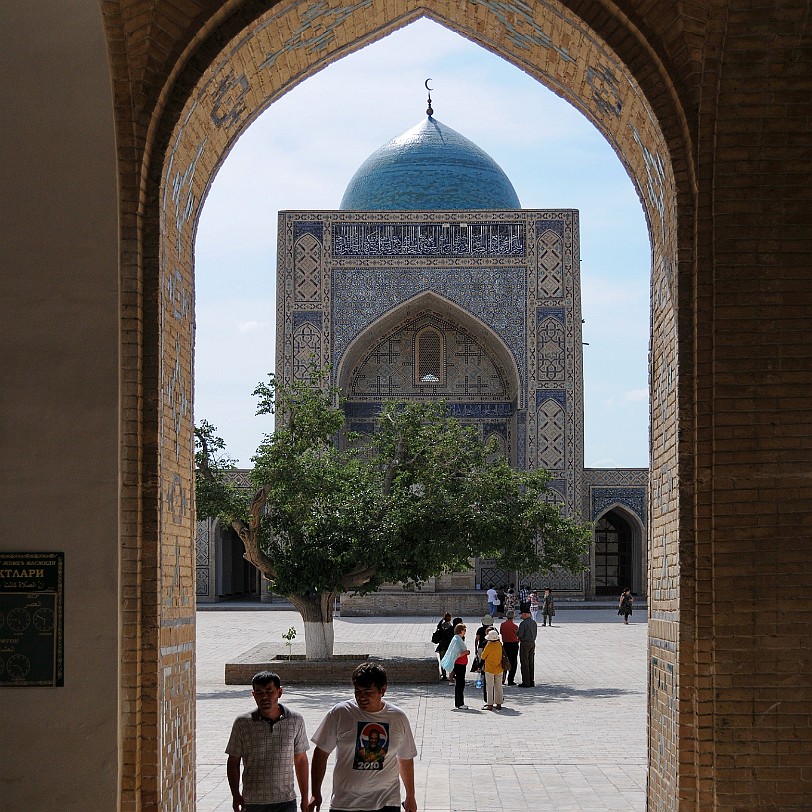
[{"xmin": 336, "ymin": 293, "xmax": 520, "ymax": 463}]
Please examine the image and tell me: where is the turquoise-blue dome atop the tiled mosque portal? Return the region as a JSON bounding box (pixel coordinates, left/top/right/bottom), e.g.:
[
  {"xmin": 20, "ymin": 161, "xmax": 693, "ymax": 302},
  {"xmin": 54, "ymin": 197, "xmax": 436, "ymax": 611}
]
[{"xmin": 341, "ymin": 116, "xmax": 521, "ymax": 211}]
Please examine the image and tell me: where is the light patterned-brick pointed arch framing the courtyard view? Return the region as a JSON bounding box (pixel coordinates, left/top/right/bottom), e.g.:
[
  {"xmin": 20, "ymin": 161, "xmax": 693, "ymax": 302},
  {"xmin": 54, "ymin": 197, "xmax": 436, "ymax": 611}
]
[{"xmin": 133, "ymin": 0, "xmax": 695, "ymax": 809}]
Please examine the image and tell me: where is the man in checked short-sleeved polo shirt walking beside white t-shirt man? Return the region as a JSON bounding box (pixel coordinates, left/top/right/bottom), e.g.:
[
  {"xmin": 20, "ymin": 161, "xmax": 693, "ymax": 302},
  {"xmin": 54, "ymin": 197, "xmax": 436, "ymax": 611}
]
[{"xmin": 226, "ymin": 671, "xmax": 310, "ymax": 812}]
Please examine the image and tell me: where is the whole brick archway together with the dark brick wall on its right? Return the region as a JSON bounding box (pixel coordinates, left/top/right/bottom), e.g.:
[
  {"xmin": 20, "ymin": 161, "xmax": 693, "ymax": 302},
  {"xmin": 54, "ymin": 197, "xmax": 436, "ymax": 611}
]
[{"xmin": 100, "ymin": 0, "xmax": 812, "ymax": 812}]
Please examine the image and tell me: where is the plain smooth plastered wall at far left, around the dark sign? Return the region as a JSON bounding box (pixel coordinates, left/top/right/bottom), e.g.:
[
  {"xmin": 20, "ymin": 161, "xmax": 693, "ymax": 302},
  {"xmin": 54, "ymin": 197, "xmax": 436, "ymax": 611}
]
[{"xmin": 0, "ymin": 2, "xmax": 122, "ymax": 812}]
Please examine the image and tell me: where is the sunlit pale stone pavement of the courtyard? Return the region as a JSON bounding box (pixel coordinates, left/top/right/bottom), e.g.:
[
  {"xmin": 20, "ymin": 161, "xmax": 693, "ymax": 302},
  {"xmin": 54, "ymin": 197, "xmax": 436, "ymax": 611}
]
[{"xmin": 197, "ymin": 608, "xmax": 647, "ymax": 812}]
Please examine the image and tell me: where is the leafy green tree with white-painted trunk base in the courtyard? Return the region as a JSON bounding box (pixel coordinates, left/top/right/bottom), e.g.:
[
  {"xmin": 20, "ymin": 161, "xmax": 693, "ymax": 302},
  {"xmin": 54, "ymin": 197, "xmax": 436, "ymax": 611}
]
[{"xmin": 196, "ymin": 369, "xmax": 589, "ymax": 658}]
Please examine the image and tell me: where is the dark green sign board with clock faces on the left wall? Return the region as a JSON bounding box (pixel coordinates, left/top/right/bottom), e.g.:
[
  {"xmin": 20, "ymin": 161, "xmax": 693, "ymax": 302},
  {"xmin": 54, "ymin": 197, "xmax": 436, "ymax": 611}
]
[{"xmin": 0, "ymin": 552, "xmax": 65, "ymax": 688}]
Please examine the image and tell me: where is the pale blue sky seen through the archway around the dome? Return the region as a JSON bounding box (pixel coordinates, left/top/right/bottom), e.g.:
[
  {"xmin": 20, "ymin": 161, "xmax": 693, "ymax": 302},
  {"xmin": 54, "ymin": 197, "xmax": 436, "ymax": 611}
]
[{"xmin": 195, "ymin": 20, "xmax": 651, "ymax": 467}]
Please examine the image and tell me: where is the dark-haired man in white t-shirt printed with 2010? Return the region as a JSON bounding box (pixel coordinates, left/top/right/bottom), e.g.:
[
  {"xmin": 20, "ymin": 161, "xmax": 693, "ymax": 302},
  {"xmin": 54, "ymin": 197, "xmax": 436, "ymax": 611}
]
[{"xmin": 310, "ymin": 663, "xmax": 417, "ymax": 812}]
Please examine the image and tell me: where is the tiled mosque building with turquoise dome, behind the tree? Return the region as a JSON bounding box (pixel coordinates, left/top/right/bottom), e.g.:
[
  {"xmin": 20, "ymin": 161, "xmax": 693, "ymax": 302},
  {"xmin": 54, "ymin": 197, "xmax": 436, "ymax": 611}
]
[{"xmin": 197, "ymin": 108, "xmax": 648, "ymax": 613}]
